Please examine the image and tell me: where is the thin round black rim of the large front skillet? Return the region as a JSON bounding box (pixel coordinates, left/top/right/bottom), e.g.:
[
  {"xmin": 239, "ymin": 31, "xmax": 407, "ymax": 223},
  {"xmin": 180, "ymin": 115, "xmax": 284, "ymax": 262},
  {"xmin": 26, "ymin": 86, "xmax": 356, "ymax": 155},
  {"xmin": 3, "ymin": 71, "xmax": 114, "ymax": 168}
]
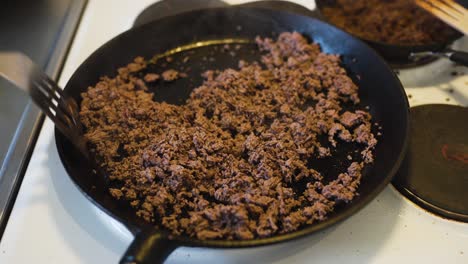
[{"xmin": 54, "ymin": 6, "xmax": 410, "ymax": 248}]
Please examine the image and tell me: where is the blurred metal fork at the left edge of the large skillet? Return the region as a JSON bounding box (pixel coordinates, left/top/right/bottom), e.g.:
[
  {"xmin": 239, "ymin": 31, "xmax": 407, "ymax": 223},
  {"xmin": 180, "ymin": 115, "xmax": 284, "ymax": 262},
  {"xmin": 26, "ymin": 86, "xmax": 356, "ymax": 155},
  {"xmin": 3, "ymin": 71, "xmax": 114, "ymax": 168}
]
[{"xmin": 0, "ymin": 52, "xmax": 89, "ymax": 158}]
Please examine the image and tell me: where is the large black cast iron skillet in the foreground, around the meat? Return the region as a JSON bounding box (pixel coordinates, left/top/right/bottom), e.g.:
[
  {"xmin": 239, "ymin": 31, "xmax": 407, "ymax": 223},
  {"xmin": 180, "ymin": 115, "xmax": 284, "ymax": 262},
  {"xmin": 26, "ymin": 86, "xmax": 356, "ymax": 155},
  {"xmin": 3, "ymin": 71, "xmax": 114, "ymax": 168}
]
[{"xmin": 55, "ymin": 7, "xmax": 409, "ymax": 263}]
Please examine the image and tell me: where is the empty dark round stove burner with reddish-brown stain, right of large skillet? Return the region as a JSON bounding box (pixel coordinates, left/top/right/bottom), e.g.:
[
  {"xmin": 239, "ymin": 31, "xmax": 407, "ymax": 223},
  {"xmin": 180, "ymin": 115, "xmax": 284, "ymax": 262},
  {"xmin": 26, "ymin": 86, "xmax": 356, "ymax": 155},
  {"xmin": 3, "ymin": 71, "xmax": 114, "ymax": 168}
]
[{"xmin": 393, "ymin": 105, "xmax": 468, "ymax": 222}]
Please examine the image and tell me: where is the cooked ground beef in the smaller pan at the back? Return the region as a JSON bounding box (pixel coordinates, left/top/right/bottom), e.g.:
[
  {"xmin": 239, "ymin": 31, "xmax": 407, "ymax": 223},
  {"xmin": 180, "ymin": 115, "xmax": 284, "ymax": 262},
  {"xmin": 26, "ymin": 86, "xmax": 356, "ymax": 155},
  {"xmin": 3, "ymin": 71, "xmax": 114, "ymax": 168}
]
[{"xmin": 322, "ymin": 0, "xmax": 457, "ymax": 45}]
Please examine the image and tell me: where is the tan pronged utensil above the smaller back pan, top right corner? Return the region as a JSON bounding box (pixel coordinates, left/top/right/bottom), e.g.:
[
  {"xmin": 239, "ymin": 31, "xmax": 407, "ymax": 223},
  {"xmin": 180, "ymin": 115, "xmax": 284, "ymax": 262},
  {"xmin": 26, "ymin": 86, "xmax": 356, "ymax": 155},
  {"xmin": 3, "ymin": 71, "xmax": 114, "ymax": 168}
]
[{"xmin": 415, "ymin": 0, "xmax": 468, "ymax": 35}]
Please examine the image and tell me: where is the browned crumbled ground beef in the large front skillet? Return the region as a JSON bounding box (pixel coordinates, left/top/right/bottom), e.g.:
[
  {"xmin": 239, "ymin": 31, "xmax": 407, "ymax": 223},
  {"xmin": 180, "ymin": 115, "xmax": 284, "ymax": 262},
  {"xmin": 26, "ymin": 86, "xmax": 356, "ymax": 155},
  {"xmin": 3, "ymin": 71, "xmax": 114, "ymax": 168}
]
[{"xmin": 80, "ymin": 32, "xmax": 377, "ymax": 240}]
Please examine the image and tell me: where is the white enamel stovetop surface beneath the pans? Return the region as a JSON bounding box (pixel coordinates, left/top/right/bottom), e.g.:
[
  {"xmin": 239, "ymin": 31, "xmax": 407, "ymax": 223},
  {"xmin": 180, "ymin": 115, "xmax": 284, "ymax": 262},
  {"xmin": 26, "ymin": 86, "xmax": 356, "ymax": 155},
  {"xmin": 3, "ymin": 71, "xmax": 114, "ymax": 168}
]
[{"xmin": 0, "ymin": 0, "xmax": 468, "ymax": 264}]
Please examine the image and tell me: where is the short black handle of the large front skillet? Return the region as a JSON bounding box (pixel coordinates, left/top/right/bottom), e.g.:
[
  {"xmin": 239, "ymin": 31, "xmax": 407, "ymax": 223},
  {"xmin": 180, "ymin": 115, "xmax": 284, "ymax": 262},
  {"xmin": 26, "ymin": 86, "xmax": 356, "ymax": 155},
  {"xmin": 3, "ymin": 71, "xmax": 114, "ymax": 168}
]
[{"xmin": 119, "ymin": 229, "xmax": 178, "ymax": 264}]
